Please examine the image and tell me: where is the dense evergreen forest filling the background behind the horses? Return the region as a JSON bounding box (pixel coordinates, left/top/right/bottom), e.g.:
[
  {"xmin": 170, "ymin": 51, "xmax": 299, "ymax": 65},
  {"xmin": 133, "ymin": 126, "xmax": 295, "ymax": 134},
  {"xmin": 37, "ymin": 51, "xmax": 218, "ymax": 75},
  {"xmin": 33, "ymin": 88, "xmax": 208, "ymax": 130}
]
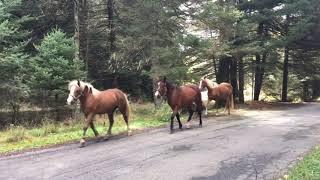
[{"xmin": 0, "ymin": 0, "xmax": 320, "ymax": 122}]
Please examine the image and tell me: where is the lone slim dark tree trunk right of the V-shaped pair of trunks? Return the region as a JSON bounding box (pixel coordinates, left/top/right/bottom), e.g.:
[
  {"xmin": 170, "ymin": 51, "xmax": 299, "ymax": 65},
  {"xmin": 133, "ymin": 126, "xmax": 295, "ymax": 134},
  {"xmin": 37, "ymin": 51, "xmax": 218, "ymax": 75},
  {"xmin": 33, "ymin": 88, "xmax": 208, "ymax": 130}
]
[{"xmin": 281, "ymin": 47, "xmax": 289, "ymax": 102}]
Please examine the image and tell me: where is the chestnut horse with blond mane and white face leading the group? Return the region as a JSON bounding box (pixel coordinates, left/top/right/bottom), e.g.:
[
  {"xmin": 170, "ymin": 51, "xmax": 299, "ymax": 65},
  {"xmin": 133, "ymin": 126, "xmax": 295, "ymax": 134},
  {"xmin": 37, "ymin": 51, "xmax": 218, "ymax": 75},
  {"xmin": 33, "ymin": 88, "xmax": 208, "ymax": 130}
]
[{"xmin": 67, "ymin": 80, "xmax": 130, "ymax": 147}]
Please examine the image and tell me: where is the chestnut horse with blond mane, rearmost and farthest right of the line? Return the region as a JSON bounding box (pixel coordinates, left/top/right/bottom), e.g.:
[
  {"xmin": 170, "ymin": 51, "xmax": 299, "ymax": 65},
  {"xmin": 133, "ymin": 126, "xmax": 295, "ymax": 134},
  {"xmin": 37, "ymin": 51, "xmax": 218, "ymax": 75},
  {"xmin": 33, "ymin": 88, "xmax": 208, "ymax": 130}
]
[{"xmin": 199, "ymin": 77, "xmax": 234, "ymax": 115}]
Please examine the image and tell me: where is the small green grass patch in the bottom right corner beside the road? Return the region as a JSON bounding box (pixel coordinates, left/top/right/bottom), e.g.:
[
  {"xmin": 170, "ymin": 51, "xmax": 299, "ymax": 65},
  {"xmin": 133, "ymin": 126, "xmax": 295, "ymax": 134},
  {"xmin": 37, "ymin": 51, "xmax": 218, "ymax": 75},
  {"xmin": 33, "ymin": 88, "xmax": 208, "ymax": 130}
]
[{"xmin": 288, "ymin": 146, "xmax": 320, "ymax": 180}]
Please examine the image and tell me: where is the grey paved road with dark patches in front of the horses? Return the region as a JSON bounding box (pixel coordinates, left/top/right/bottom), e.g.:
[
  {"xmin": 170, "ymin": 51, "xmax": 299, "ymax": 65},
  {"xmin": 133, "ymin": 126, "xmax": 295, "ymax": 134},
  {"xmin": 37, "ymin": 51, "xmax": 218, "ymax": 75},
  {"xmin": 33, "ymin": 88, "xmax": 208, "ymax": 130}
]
[{"xmin": 0, "ymin": 104, "xmax": 320, "ymax": 180}]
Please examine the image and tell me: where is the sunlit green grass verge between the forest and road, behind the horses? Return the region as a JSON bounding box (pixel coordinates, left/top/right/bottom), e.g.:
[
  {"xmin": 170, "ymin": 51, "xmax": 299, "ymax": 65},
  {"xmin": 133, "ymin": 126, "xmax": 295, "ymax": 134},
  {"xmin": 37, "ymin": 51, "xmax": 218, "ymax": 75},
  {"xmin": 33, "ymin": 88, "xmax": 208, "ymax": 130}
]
[{"xmin": 0, "ymin": 103, "xmax": 175, "ymax": 154}]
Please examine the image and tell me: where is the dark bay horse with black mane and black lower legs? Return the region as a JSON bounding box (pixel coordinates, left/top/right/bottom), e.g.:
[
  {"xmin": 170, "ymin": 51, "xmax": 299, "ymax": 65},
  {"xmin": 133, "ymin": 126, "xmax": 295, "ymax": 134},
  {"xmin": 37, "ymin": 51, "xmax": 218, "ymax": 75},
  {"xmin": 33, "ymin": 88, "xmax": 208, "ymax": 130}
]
[{"xmin": 155, "ymin": 77, "xmax": 203, "ymax": 134}]
